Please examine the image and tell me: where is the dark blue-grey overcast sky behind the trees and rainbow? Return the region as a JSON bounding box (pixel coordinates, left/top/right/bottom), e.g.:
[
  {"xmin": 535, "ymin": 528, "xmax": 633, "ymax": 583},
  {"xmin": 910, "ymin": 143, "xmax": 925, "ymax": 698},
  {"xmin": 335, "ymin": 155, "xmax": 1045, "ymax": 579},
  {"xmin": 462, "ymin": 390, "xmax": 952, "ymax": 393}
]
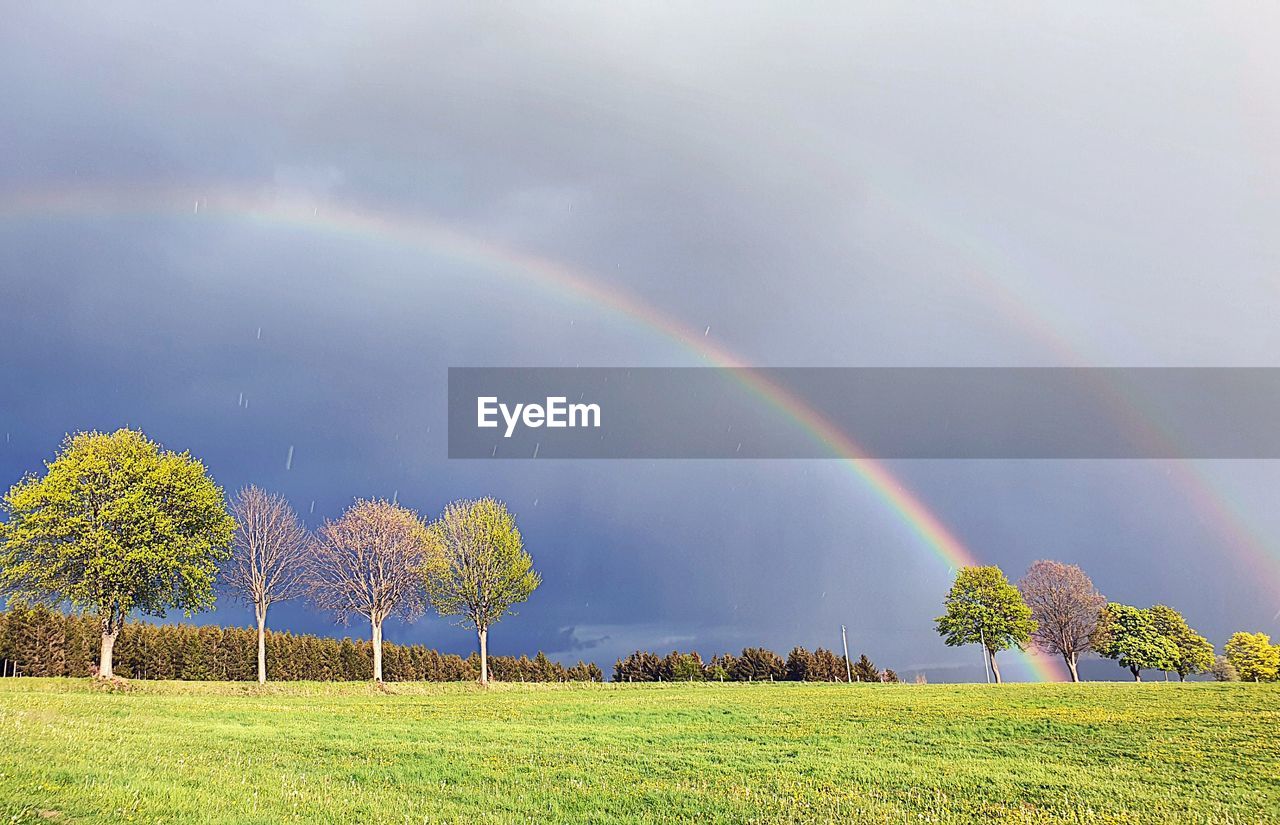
[{"xmin": 0, "ymin": 3, "xmax": 1280, "ymax": 680}]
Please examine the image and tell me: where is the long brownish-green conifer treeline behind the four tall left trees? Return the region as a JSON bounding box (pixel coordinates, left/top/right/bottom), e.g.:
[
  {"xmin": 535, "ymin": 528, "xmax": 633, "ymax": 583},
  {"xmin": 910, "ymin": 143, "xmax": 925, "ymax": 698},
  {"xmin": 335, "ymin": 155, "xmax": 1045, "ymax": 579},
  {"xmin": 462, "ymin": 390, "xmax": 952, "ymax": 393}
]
[{"xmin": 0, "ymin": 605, "xmax": 604, "ymax": 682}]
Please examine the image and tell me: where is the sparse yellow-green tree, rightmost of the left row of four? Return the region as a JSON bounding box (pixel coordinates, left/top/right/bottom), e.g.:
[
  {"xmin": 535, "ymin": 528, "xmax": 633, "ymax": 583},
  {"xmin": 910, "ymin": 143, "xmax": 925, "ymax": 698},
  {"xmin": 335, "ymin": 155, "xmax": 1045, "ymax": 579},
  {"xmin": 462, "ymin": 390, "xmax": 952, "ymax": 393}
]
[{"xmin": 422, "ymin": 498, "xmax": 543, "ymax": 686}]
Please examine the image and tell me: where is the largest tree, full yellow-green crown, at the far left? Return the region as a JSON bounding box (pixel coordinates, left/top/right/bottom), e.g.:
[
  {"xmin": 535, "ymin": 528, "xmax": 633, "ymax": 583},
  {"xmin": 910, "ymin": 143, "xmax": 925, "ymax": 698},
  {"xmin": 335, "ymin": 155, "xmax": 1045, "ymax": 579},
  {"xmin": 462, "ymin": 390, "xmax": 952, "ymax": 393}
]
[{"xmin": 0, "ymin": 430, "xmax": 236, "ymax": 678}]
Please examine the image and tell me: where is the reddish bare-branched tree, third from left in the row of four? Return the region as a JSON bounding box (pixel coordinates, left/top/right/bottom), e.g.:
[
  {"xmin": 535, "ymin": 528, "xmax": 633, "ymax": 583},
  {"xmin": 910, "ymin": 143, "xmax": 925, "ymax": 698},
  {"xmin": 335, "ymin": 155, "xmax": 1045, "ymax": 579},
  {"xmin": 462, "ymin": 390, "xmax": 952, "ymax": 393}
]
[{"xmin": 306, "ymin": 500, "xmax": 428, "ymax": 682}]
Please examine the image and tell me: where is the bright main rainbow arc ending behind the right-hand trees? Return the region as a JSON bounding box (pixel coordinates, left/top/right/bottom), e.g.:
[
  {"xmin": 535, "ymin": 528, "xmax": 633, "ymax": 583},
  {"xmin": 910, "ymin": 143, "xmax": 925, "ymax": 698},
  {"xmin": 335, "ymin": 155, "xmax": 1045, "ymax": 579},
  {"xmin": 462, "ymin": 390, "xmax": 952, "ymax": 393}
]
[{"xmin": 0, "ymin": 182, "xmax": 1066, "ymax": 680}]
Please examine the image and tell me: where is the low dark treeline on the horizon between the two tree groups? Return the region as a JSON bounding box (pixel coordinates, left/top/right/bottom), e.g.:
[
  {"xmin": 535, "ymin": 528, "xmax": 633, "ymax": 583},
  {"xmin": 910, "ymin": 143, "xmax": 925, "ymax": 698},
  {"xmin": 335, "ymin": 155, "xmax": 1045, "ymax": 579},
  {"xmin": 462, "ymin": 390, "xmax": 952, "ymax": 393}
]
[{"xmin": 613, "ymin": 647, "xmax": 899, "ymax": 683}]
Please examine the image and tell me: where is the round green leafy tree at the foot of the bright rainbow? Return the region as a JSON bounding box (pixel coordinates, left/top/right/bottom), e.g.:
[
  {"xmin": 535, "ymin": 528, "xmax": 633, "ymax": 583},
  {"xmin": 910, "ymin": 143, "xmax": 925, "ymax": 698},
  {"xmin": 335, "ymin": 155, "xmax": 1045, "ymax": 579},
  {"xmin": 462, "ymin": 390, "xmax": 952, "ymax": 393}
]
[{"xmin": 934, "ymin": 567, "xmax": 1037, "ymax": 684}]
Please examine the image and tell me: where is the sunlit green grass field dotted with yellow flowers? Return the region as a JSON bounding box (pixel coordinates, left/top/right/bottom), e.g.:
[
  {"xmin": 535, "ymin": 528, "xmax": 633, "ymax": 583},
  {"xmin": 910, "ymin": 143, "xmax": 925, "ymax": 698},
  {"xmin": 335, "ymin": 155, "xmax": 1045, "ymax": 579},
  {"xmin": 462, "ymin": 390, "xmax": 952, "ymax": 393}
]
[{"xmin": 0, "ymin": 679, "xmax": 1280, "ymax": 822}]
